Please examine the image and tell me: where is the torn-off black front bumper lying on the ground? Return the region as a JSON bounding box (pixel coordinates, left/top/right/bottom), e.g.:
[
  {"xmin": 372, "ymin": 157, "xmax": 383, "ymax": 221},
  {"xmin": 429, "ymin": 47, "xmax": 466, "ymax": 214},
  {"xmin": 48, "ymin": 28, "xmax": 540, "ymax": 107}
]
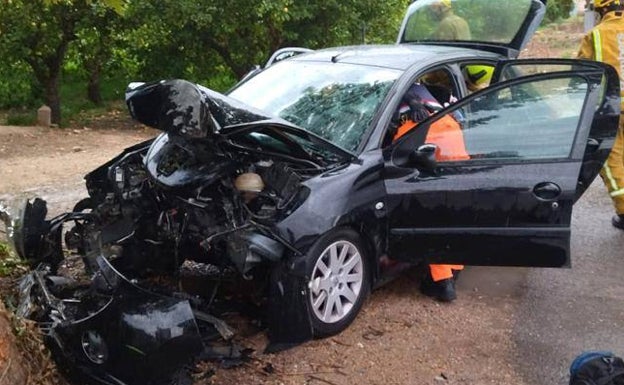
[{"xmin": 17, "ymin": 257, "xmax": 204, "ymax": 384}]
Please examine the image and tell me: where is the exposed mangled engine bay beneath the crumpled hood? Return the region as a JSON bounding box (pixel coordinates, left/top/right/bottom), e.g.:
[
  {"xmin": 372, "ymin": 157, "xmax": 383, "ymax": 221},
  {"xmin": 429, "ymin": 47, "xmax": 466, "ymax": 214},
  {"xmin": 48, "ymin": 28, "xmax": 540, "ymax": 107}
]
[{"xmin": 65, "ymin": 139, "xmax": 320, "ymax": 275}]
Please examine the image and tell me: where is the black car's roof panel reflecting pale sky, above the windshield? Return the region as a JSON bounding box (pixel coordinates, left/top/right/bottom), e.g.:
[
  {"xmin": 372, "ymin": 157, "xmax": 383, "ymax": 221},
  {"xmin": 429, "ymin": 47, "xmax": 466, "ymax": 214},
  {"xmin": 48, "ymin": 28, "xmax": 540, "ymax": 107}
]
[{"xmin": 288, "ymin": 44, "xmax": 501, "ymax": 71}]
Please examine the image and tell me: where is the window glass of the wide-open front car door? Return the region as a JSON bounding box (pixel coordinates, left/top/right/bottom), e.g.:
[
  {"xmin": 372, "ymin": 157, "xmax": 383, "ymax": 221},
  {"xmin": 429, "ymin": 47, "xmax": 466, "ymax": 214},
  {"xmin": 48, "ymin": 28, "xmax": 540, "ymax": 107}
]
[{"xmin": 427, "ymin": 77, "xmax": 587, "ymax": 162}]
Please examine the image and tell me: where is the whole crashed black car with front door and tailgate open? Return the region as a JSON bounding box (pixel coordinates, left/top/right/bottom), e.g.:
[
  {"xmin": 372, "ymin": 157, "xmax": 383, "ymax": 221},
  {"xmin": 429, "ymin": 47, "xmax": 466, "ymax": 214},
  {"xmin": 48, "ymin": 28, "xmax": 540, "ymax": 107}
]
[{"xmin": 0, "ymin": 0, "xmax": 620, "ymax": 384}]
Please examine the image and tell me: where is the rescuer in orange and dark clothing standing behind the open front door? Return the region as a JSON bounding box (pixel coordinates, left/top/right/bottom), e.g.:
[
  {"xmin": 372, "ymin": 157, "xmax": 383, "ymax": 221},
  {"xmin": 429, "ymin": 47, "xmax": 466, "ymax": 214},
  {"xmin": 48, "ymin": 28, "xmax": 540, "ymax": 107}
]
[{"xmin": 394, "ymin": 83, "xmax": 470, "ymax": 302}]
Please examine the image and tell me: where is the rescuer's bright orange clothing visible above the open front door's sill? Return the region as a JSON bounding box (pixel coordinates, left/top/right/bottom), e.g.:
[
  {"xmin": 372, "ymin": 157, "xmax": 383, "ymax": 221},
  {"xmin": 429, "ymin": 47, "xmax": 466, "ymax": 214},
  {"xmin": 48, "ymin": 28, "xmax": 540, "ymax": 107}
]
[{"xmin": 394, "ymin": 115, "xmax": 470, "ymax": 161}]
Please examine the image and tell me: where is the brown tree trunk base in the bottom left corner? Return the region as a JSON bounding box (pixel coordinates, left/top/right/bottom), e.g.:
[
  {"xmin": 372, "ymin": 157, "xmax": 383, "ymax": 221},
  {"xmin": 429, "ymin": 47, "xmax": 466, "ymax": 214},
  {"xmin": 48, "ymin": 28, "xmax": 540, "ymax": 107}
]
[{"xmin": 0, "ymin": 301, "xmax": 28, "ymax": 385}]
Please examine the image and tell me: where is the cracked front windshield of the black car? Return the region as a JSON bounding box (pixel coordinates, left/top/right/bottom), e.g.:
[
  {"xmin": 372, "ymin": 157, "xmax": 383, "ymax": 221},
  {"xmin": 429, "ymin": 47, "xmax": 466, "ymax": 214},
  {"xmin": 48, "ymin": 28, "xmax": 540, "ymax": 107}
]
[{"xmin": 229, "ymin": 60, "xmax": 402, "ymax": 151}]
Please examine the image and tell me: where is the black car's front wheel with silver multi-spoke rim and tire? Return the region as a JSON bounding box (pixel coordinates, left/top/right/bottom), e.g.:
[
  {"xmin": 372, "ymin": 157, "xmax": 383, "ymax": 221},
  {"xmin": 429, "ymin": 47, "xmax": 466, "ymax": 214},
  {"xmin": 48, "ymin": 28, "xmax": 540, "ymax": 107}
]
[{"xmin": 307, "ymin": 228, "xmax": 371, "ymax": 337}]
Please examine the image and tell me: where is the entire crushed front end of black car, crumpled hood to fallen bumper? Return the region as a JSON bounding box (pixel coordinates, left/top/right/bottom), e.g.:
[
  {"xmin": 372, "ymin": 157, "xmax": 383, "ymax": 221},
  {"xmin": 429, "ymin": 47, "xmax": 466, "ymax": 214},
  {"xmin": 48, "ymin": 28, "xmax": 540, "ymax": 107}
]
[{"xmin": 0, "ymin": 81, "xmax": 352, "ymax": 384}]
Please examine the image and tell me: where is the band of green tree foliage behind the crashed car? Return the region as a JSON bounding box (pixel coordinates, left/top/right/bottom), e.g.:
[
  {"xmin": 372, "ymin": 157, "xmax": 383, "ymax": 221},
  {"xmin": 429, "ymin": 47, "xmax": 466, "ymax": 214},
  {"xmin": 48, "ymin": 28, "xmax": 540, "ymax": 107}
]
[{"xmin": 0, "ymin": 0, "xmax": 409, "ymax": 118}]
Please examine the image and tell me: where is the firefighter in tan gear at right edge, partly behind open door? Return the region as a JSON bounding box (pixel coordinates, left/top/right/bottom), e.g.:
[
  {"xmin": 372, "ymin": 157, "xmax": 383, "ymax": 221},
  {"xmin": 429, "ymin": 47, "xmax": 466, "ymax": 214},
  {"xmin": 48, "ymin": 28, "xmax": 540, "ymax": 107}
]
[{"xmin": 578, "ymin": 0, "xmax": 624, "ymax": 230}]
